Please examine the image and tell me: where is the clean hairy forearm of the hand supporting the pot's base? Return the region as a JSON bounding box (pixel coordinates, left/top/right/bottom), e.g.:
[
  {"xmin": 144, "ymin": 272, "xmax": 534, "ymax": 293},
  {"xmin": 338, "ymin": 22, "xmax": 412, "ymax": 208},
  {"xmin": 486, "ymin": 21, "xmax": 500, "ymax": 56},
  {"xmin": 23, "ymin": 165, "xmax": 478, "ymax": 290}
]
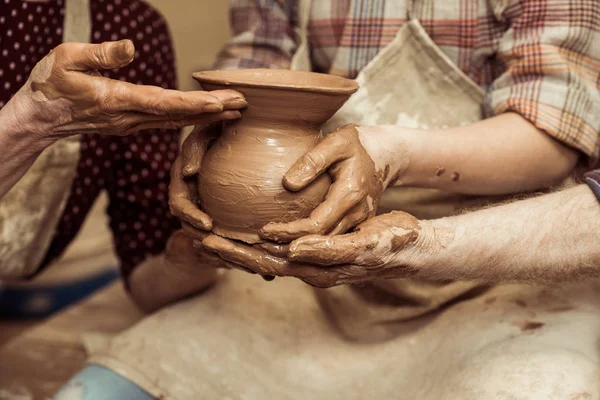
[{"xmin": 406, "ymin": 185, "xmax": 600, "ymax": 283}]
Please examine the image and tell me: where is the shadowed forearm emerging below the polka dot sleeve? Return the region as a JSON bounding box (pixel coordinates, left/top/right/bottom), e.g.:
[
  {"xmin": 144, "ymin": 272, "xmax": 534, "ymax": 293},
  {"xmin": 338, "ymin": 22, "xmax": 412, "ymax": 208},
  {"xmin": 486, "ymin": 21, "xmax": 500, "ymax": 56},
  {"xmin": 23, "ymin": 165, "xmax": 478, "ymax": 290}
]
[{"xmin": 128, "ymin": 254, "xmax": 220, "ymax": 313}]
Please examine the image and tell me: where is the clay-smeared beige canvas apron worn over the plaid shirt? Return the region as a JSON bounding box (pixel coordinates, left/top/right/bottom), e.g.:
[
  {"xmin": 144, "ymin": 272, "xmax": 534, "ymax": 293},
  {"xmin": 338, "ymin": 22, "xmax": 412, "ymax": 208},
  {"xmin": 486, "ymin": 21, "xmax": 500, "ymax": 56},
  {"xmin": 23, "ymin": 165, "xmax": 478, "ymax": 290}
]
[{"xmin": 89, "ymin": 1, "xmax": 600, "ymax": 400}]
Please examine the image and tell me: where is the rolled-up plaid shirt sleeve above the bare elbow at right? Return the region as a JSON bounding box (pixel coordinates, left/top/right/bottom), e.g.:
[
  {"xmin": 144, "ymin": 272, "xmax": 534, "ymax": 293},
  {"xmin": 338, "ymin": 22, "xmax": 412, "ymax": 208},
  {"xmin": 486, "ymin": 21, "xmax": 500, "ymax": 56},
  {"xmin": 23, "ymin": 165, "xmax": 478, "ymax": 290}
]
[{"xmin": 487, "ymin": 0, "xmax": 600, "ymax": 165}]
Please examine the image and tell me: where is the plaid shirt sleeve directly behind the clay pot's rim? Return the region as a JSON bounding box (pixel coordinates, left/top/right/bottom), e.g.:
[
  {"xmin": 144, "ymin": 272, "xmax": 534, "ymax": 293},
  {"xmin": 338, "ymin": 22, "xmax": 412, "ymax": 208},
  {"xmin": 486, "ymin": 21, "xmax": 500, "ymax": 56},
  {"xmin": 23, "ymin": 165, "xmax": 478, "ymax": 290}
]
[{"xmin": 215, "ymin": 0, "xmax": 297, "ymax": 69}]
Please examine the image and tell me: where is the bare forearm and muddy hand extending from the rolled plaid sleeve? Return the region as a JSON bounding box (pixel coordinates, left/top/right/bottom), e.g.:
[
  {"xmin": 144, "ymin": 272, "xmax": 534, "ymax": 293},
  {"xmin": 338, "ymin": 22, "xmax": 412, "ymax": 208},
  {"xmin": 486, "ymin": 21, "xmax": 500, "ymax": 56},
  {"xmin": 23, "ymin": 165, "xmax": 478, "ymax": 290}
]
[{"xmin": 259, "ymin": 113, "xmax": 577, "ymax": 242}]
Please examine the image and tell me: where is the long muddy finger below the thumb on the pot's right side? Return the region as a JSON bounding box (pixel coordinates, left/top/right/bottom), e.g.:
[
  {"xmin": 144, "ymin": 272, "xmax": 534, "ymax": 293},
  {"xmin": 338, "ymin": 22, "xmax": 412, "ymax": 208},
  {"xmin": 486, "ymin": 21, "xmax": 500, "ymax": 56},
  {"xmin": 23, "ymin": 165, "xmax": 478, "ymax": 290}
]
[{"xmin": 258, "ymin": 179, "xmax": 364, "ymax": 242}]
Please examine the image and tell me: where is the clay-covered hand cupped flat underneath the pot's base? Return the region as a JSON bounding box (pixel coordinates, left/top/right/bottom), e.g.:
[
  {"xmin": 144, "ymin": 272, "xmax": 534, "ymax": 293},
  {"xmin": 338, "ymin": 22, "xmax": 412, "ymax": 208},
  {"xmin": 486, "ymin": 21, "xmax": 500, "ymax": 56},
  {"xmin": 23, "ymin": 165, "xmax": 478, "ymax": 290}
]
[{"xmin": 202, "ymin": 211, "xmax": 421, "ymax": 287}]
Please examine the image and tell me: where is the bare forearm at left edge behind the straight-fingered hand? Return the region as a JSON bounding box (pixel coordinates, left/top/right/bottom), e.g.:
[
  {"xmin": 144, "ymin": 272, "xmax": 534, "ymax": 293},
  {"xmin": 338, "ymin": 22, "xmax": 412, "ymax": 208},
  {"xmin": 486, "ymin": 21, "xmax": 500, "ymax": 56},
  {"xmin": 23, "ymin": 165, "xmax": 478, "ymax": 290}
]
[{"xmin": 0, "ymin": 94, "xmax": 52, "ymax": 198}]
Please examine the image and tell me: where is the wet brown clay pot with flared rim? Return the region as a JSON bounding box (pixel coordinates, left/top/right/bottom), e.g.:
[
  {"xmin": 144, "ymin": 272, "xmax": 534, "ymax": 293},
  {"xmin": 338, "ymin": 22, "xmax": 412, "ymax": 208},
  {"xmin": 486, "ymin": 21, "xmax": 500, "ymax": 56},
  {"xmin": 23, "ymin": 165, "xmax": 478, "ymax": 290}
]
[{"xmin": 194, "ymin": 69, "xmax": 358, "ymax": 243}]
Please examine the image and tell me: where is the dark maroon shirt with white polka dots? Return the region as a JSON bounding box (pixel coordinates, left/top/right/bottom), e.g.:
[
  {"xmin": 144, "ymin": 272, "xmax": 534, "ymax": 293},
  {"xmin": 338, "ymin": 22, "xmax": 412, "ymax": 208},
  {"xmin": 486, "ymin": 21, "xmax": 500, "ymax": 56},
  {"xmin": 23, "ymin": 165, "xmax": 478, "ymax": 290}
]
[{"xmin": 0, "ymin": 0, "xmax": 180, "ymax": 277}]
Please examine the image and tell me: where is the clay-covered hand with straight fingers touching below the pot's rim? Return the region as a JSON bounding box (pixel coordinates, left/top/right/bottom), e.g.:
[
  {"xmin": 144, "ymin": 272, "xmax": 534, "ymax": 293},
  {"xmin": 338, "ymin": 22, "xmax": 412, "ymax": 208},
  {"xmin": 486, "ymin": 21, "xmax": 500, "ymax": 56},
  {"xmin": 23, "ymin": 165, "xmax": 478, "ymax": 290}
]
[{"xmin": 7, "ymin": 40, "xmax": 246, "ymax": 139}]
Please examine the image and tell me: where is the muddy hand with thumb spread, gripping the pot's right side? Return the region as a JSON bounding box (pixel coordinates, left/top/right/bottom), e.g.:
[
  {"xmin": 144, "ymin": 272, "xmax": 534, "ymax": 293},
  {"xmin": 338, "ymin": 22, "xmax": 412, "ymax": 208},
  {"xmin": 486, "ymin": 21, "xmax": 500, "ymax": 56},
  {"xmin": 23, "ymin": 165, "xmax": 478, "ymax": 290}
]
[{"xmin": 259, "ymin": 124, "xmax": 396, "ymax": 242}]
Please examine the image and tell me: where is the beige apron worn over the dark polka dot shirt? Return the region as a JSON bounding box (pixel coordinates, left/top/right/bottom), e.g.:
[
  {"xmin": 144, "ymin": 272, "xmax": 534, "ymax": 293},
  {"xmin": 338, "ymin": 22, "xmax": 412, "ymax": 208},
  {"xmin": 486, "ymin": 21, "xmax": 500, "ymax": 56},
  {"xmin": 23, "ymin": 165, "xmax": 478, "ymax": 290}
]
[{"xmin": 0, "ymin": 0, "xmax": 91, "ymax": 279}]
